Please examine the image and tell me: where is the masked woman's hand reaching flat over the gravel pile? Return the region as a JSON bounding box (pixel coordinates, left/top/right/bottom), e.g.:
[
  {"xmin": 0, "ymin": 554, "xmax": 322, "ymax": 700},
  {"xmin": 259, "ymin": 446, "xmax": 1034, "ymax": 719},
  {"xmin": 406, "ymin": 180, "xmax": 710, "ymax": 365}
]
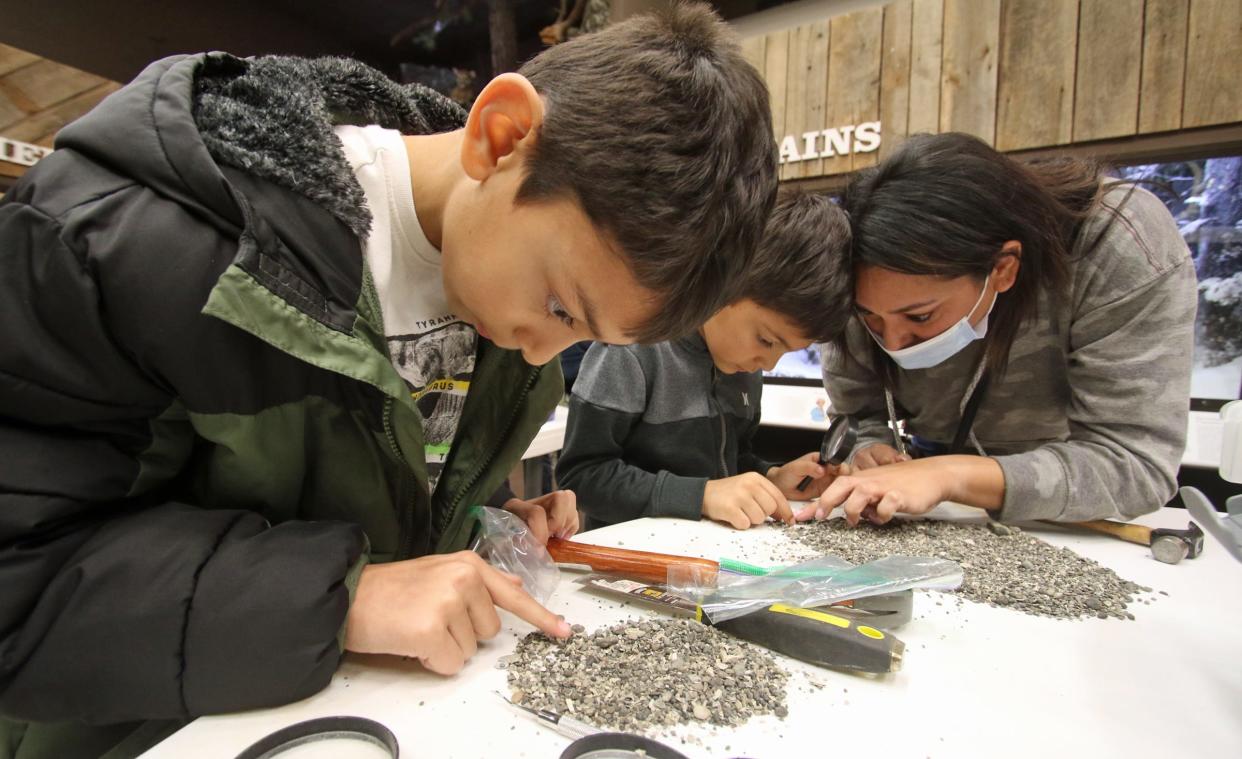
[{"xmin": 794, "ymin": 456, "xmax": 1005, "ymax": 525}]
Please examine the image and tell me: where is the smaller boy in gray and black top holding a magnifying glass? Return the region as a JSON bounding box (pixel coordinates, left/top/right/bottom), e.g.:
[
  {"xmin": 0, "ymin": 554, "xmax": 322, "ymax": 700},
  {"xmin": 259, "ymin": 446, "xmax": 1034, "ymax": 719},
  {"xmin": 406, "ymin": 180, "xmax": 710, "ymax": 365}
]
[{"xmin": 556, "ymin": 193, "xmax": 853, "ymax": 529}]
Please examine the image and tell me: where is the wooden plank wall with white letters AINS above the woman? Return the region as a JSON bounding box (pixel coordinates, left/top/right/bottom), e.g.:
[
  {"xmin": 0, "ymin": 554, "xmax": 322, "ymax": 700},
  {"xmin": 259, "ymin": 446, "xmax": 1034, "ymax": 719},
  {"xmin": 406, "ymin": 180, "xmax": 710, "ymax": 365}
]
[{"xmin": 744, "ymin": 0, "xmax": 1242, "ymax": 179}]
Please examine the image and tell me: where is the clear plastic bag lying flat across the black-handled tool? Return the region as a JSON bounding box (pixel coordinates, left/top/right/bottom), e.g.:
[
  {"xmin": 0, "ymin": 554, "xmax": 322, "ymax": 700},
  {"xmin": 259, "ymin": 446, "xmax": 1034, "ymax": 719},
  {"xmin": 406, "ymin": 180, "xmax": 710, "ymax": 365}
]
[{"xmin": 668, "ymin": 555, "xmax": 963, "ymax": 622}]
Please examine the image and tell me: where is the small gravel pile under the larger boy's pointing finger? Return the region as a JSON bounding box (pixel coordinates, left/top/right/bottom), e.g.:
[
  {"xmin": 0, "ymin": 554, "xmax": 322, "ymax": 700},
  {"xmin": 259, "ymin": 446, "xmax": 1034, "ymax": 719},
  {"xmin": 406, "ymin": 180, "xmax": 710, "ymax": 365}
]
[{"xmin": 499, "ymin": 620, "xmax": 789, "ymax": 732}]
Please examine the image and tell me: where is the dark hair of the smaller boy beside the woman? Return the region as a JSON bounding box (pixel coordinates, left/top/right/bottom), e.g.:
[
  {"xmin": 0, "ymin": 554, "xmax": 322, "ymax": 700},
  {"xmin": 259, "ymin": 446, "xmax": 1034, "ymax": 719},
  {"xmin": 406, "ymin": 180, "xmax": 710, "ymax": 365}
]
[{"xmin": 741, "ymin": 190, "xmax": 853, "ymax": 343}]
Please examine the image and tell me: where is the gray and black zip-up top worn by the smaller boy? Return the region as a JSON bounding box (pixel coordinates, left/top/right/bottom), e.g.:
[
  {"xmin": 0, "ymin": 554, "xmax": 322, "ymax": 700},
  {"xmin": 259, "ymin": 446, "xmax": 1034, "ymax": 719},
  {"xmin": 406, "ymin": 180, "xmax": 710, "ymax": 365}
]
[{"xmin": 556, "ymin": 333, "xmax": 771, "ymax": 529}]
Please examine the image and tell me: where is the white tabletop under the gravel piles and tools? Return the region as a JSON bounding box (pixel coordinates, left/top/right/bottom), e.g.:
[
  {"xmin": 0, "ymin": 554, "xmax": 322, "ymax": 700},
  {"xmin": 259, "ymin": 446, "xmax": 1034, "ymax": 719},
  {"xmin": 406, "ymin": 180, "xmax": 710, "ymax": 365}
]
[{"xmin": 138, "ymin": 504, "xmax": 1242, "ymax": 759}]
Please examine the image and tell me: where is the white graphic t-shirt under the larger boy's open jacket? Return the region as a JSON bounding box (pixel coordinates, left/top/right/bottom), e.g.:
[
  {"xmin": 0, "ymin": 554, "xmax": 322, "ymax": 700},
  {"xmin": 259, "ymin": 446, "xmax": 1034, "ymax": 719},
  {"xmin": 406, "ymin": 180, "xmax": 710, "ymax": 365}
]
[{"xmin": 335, "ymin": 125, "xmax": 478, "ymax": 491}]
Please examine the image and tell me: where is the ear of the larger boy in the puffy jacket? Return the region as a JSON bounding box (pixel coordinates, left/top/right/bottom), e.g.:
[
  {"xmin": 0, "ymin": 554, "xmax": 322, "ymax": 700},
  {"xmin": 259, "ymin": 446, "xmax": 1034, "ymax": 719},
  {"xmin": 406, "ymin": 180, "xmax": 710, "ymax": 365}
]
[{"xmin": 462, "ymin": 73, "xmax": 544, "ymax": 181}]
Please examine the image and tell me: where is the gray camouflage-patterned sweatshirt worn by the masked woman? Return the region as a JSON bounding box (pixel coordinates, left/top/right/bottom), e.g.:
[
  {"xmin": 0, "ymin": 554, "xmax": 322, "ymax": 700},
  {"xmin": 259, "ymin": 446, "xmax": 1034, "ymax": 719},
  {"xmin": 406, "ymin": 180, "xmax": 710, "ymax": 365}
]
[{"xmin": 823, "ymin": 186, "xmax": 1197, "ymax": 520}]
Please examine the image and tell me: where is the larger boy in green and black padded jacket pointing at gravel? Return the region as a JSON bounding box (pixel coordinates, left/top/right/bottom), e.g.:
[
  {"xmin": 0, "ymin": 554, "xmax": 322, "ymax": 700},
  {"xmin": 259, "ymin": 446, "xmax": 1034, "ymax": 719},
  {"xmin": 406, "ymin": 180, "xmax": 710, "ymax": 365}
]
[{"xmin": 0, "ymin": 5, "xmax": 775, "ymax": 757}]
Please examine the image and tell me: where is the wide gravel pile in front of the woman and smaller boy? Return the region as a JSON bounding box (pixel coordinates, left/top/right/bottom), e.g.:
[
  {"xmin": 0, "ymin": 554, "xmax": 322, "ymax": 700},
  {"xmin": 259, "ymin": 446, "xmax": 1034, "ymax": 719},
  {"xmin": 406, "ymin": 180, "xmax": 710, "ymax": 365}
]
[{"xmin": 786, "ymin": 519, "xmax": 1151, "ymax": 620}]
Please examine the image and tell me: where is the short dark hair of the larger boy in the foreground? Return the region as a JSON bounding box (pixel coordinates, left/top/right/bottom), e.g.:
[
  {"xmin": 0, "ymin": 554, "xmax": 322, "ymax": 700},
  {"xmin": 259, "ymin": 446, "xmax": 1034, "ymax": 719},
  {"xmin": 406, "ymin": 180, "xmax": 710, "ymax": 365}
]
[{"xmin": 518, "ymin": 4, "xmax": 776, "ymax": 343}]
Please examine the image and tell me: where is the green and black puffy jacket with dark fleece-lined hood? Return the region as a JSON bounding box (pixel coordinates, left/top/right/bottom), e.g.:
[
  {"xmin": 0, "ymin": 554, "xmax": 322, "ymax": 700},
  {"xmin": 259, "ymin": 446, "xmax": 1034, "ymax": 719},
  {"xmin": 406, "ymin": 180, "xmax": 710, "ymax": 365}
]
[{"xmin": 0, "ymin": 53, "xmax": 561, "ymax": 724}]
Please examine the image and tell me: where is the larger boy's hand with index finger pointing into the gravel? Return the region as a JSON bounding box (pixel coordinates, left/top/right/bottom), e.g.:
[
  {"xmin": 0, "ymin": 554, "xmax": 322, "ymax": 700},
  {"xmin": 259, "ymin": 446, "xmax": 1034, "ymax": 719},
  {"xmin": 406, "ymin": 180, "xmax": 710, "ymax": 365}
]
[{"xmin": 345, "ymin": 550, "xmax": 570, "ymax": 675}]
